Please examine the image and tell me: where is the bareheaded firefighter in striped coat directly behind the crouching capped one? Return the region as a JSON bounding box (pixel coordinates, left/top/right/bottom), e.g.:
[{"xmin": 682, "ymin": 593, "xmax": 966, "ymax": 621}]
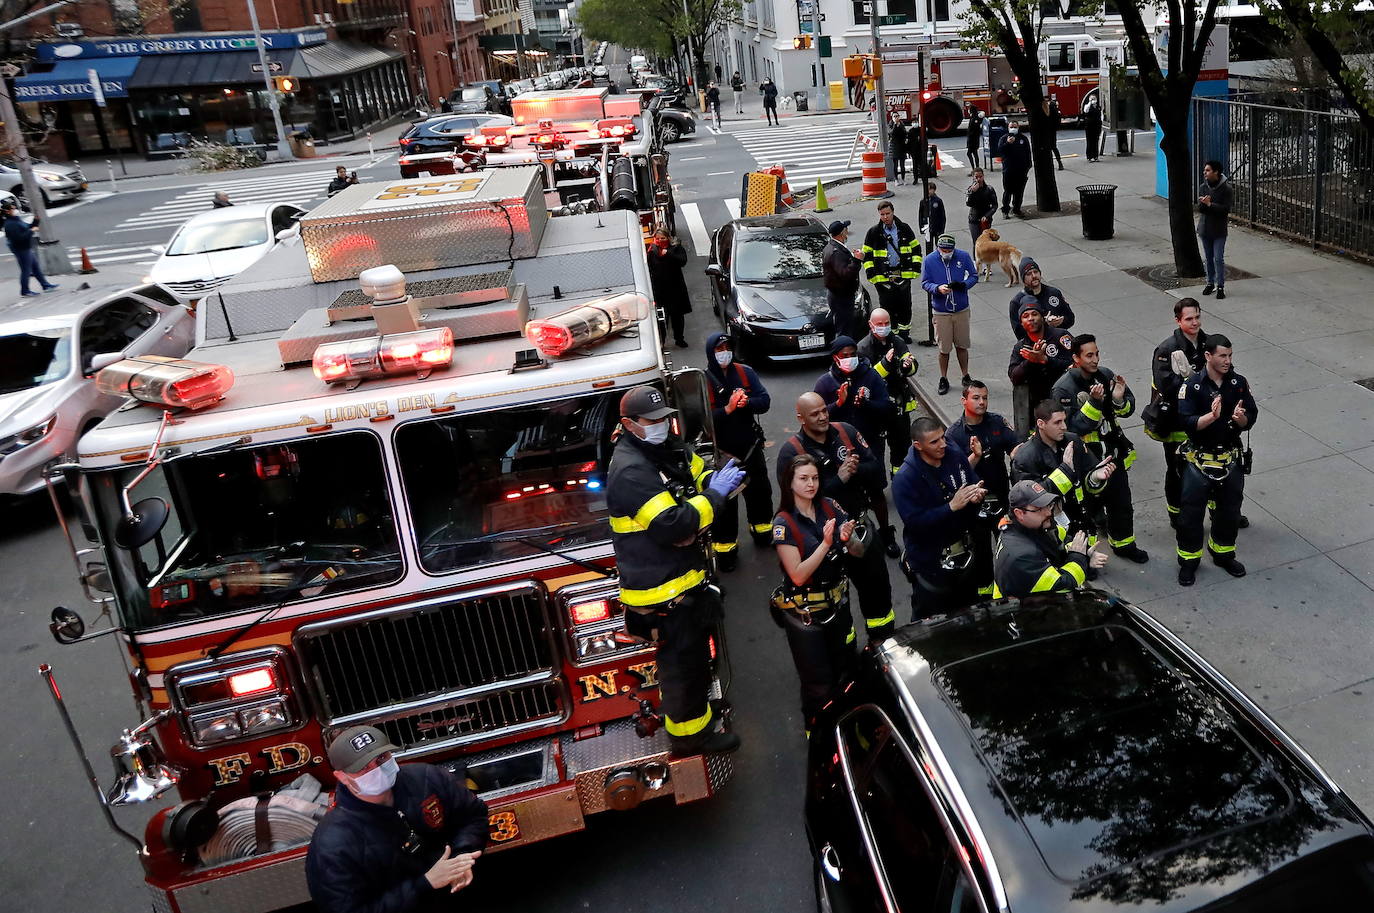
[{"xmin": 1011, "ymin": 399, "xmax": 1116, "ymax": 550}]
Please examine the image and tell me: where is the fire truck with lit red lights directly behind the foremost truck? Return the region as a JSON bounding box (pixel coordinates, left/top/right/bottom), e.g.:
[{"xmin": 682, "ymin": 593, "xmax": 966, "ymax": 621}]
[{"xmin": 401, "ymin": 87, "xmax": 676, "ymax": 235}]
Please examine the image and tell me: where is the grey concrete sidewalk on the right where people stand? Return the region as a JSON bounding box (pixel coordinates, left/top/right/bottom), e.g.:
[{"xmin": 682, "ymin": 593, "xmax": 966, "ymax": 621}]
[{"xmin": 820, "ymin": 138, "xmax": 1374, "ymax": 809}]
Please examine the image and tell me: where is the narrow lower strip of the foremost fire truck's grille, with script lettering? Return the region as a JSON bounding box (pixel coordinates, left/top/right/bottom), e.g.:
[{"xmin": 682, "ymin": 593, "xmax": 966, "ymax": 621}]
[{"xmin": 376, "ymin": 682, "xmax": 563, "ymax": 754}]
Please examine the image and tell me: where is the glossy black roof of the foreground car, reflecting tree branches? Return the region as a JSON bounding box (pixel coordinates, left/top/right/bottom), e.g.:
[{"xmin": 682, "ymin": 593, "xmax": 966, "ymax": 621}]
[{"xmin": 881, "ymin": 593, "xmax": 1374, "ymax": 913}]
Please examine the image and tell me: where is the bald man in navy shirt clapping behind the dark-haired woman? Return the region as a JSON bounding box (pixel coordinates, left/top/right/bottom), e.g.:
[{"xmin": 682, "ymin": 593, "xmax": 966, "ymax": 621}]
[{"xmin": 778, "ymin": 393, "xmax": 896, "ymax": 641}]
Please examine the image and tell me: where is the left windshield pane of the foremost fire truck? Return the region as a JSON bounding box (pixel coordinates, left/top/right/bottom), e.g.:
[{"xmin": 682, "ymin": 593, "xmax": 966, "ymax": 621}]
[{"xmin": 91, "ymin": 432, "xmax": 403, "ymax": 630}]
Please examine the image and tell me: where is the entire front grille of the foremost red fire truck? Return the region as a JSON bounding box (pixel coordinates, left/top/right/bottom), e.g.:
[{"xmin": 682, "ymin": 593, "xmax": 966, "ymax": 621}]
[{"xmin": 295, "ymin": 583, "xmax": 558, "ymax": 747}]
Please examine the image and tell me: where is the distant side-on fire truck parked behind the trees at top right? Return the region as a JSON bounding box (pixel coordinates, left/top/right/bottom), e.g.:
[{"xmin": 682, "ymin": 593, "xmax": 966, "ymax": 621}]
[{"xmin": 886, "ymin": 33, "xmax": 1125, "ymax": 138}]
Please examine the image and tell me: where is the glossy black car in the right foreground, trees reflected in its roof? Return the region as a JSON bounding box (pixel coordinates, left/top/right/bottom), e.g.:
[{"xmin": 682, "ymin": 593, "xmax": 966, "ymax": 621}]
[{"xmin": 807, "ymin": 591, "xmax": 1374, "ymax": 913}]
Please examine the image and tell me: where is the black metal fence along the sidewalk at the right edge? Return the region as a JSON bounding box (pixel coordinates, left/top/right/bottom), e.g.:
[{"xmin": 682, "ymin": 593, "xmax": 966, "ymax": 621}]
[{"xmin": 1193, "ymin": 92, "xmax": 1374, "ymax": 260}]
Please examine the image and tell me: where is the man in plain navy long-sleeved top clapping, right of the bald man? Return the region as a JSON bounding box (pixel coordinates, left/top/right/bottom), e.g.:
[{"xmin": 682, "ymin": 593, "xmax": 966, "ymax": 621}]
[{"xmin": 892, "ymin": 415, "xmax": 992, "ymax": 619}]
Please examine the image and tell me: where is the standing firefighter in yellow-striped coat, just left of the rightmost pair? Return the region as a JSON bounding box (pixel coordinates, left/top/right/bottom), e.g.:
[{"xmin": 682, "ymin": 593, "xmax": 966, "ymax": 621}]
[{"xmin": 1050, "ymin": 333, "xmax": 1150, "ymax": 564}]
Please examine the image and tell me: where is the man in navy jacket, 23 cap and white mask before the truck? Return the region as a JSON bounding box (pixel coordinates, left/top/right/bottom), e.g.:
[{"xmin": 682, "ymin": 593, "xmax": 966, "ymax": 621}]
[{"xmin": 305, "ymin": 726, "xmax": 488, "ymax": 913}]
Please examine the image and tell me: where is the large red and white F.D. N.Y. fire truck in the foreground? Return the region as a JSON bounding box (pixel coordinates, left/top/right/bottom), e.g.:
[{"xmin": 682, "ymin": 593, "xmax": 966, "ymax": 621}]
[{"xmin": 43, "ymin": 166, "xmax": 731, "ymax": 913}]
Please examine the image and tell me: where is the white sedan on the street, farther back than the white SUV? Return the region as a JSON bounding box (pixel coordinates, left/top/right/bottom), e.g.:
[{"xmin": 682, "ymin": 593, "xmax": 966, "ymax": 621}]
[{"xmin": 147, "ymin": 204, "xmax": 305, "ymax": 301}]
